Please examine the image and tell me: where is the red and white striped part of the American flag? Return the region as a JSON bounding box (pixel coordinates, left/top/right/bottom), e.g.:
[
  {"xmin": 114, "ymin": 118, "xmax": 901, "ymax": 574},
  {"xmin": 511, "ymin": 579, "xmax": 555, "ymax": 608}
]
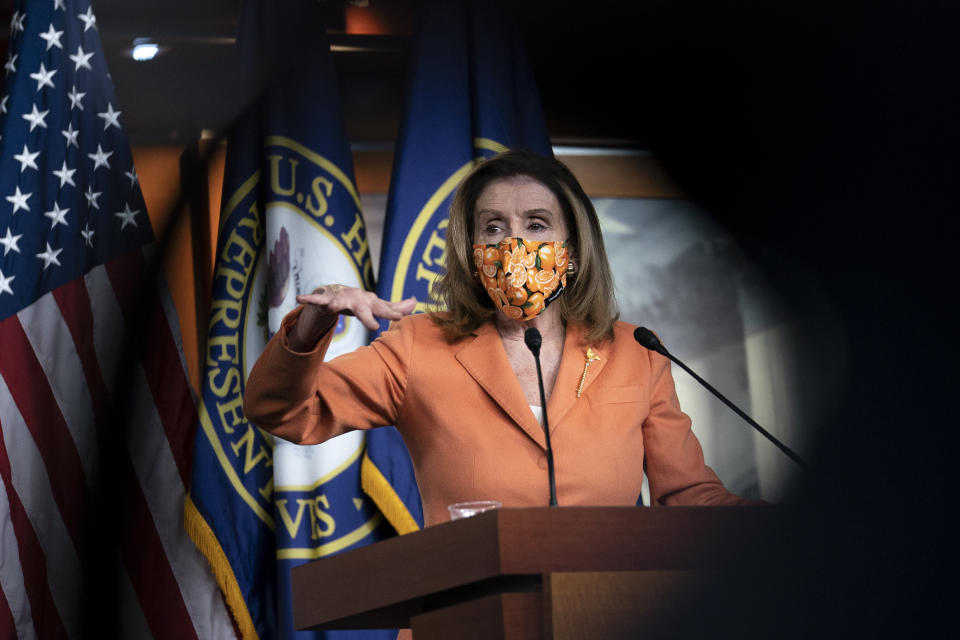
[{"xmin": 0, "ymin": 252, "xmax": 235, "ymax": 639}]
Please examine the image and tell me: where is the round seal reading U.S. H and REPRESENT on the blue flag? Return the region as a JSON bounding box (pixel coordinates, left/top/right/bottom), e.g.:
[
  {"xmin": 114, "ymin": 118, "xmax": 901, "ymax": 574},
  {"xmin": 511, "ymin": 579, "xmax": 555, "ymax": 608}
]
[{"xmin": 201, "ymin": 136, "xmax": 382, "ymax": 559}]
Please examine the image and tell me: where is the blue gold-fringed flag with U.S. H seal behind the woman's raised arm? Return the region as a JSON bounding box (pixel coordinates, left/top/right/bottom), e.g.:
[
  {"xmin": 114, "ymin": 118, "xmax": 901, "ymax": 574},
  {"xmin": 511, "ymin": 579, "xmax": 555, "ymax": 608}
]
[{"xmin": 187, "ymin": 0, "xmax": 404, "ymax": 640}]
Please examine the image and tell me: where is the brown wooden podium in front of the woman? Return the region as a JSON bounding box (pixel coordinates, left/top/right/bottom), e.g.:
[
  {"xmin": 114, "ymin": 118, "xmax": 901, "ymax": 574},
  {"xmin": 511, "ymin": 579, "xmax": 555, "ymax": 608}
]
[{"xmin": 292, "ymin": 507, "xmax": 778, "ymax": 640}]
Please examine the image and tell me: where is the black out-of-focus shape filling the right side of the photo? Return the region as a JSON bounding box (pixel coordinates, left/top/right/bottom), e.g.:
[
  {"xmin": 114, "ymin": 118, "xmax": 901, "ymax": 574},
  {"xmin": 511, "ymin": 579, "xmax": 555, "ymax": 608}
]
[{"xmin": 631, "ymin": 3, "xmax": 960, "ymax": 637}]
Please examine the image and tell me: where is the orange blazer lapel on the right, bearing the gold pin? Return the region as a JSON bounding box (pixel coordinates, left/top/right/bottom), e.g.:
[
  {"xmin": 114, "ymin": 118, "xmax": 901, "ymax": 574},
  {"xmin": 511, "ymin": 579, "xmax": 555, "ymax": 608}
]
[{"xmin": 547, "ymin": 326, "xmax": 607, "ymax": 433}]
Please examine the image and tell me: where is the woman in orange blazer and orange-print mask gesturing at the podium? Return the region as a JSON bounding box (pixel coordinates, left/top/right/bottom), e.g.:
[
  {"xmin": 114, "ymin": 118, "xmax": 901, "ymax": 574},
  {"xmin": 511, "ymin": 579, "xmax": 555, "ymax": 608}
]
[{"xmin": 244, "ymin": 151, "xmax": 747, "ymax": 526}]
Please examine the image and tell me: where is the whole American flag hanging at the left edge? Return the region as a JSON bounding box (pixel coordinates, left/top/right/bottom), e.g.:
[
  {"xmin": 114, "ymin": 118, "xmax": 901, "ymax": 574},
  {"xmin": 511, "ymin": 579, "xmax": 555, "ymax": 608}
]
[{"xmin": 0, "ymin": 0, "xmax": 234, "ymax": 638}]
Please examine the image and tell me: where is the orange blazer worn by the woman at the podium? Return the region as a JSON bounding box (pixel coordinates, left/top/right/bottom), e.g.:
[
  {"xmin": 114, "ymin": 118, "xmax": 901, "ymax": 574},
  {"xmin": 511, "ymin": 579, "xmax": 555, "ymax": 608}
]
[{"xmin": 244, "ymin": 309, "xmax": 746, "ymax": 526}]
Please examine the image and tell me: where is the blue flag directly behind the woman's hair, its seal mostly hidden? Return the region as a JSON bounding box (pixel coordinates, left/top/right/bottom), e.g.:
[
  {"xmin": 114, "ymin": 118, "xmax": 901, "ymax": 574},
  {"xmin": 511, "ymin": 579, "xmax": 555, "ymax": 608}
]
[{"xmin": 365, "ymin": 0, "xmax": 553, "ymax": 533}]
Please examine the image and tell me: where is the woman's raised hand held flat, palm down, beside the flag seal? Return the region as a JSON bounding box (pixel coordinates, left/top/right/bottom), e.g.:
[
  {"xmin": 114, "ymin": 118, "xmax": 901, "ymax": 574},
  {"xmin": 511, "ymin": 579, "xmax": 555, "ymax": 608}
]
[{"xmin": 288, "ymin": 284, "xmax": 417, "ymax": 352}]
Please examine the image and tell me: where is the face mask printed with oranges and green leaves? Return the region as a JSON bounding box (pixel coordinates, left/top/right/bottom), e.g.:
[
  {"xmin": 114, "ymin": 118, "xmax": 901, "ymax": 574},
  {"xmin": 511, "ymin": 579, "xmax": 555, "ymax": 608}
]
[{"xmin": 473, "ymin": 238, "xmax": 570, "ymax": 321}]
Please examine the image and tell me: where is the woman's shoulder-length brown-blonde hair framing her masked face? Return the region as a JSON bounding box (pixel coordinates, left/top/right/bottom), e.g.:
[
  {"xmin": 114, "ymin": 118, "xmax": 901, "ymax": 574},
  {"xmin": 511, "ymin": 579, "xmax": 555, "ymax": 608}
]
[{"xmin": 432, "ymin": 150, "xmax": 620, "ymax": 341}]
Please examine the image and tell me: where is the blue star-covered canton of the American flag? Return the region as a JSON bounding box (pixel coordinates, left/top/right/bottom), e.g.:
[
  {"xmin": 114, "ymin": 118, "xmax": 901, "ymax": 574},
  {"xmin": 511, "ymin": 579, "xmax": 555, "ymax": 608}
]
[{"xmin": 0, "ymin": 1, "xmax": 153, "ymax": 320}]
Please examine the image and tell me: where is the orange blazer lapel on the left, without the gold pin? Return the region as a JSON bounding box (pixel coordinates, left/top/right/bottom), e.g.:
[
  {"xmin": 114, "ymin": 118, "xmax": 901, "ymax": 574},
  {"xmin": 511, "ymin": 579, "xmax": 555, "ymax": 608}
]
[{"xmin": 456, "ymin": 322, "xmax": 544, "ymax": 447}]
